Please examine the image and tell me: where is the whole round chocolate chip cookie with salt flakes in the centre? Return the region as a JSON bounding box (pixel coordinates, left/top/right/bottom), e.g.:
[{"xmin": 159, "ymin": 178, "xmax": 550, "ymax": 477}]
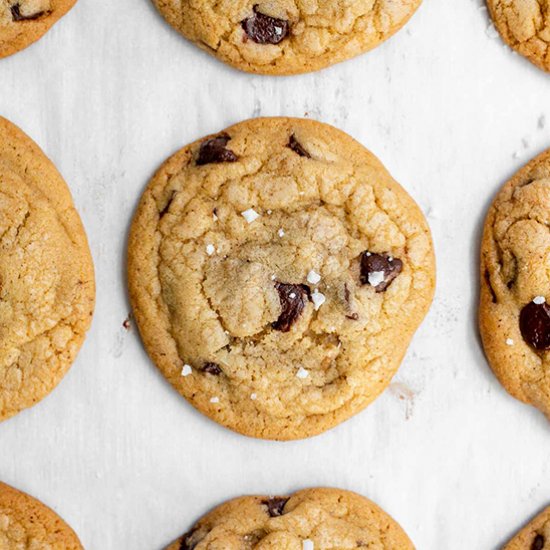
[{"xmin": 128, "ymin": 118, "xmax": 434, "ymax": 439}]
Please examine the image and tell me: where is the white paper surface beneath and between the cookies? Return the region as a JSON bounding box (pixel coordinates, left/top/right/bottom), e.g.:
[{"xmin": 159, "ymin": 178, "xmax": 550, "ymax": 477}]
[{"xmin": 0, "ymin": 0, "xmax": 550, "ymax": 550}]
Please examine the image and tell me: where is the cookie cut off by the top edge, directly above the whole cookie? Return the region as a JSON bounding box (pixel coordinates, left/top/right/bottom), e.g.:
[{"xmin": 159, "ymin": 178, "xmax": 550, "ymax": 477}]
[{"xmin": 153, "ymin": 0, "xmax": 422, "ymax": 75}]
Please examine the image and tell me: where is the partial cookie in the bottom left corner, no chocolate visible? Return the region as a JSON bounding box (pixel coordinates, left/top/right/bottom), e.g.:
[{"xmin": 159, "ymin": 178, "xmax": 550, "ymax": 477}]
[{"xmin": 0, "ymin": 483, "xmax": 82, "ymax": 550}]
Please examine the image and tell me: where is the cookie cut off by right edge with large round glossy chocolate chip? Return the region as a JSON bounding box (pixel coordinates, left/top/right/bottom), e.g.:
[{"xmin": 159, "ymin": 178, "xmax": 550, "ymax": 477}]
[{"xmin": 479, "ymin": 151, "xmax": 550, "ymax": 417}]
